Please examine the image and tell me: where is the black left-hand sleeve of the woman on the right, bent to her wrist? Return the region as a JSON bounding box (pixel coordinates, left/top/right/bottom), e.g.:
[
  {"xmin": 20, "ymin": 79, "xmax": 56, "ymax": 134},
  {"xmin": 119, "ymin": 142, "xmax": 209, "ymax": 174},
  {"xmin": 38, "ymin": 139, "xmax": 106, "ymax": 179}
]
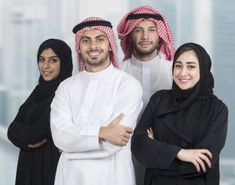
[{"xmin": 131, "ymin": 94, "xmax": 181, "ymax": 169}]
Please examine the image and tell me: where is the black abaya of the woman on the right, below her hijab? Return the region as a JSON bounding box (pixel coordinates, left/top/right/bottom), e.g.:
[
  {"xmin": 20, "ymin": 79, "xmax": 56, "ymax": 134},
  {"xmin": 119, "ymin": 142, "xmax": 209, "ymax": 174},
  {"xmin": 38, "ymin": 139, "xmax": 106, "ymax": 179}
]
[{"xmin": 132, "ymin": 91, "xmax": 228, "ymax": 185}]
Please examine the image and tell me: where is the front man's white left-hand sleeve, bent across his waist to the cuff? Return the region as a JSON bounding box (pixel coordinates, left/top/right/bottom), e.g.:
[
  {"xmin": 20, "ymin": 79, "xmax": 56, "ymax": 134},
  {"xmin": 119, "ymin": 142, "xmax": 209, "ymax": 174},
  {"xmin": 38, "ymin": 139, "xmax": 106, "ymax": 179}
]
[{"xmin": 50, "ymin": 85, "xmax": 101, "ymax": 152}]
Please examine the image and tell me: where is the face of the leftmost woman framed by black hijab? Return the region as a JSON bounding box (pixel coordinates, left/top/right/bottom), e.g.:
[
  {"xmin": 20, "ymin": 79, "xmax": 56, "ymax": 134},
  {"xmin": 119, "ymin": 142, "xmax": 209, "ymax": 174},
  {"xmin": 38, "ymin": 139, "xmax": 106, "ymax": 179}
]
[{"xmin": 38, "ymin": 48, "xmax": 61, "ymax": 81}]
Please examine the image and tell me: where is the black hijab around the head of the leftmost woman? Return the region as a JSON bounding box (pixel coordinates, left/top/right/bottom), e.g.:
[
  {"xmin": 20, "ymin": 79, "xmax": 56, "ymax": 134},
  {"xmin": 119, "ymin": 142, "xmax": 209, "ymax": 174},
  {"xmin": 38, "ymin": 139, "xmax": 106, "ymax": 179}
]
[{"xmin": 33, "ymin": 39, "xmax": 73, "ymax": 101}]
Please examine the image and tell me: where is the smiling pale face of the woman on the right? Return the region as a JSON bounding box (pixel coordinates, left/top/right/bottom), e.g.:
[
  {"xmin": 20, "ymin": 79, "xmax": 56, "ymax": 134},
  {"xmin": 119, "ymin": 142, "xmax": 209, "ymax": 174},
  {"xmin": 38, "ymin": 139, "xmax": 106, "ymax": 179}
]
[{"xmin": 173, "ymin": 50, "xmax": 200, "ymax": 90}]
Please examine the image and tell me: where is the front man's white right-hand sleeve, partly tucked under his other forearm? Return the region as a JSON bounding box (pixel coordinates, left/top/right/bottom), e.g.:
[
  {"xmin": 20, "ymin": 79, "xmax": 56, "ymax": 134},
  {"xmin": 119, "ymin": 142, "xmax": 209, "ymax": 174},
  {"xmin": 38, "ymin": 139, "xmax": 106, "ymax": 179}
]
[{"xmin": 66, "ymin": 80, "xmax": 143, "ymax": 159}]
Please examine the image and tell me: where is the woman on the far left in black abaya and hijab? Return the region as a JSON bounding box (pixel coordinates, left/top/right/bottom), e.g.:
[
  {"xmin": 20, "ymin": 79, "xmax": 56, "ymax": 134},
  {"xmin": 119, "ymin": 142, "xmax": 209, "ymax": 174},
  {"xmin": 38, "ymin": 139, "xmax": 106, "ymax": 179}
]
[{"xmin": 8, "ymin": 39, "xmax": 73, "ymax": 185}]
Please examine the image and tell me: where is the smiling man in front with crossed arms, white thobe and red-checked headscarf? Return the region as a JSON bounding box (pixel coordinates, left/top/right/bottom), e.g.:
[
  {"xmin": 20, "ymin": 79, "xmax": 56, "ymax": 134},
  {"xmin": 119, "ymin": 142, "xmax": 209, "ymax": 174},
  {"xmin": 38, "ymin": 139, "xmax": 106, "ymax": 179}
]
[{"xmin": 51, "ymin": 17, "xmax": 143, "ymax": 185}]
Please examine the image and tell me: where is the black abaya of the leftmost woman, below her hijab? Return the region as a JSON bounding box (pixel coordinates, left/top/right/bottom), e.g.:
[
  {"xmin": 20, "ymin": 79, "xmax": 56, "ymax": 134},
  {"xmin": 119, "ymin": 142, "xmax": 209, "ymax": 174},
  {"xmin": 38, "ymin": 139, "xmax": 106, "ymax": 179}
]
[{"xmin": 8, "ymin": 95, "xmax": 60, "ymax": 185}]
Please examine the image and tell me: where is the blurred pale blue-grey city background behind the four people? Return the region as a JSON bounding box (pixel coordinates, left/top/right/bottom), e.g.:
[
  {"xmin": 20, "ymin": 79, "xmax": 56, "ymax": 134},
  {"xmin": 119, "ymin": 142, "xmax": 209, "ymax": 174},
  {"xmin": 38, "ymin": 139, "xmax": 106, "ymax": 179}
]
[{"xmin": 0, "ymin": 0, "xmax": 235, "ymax": 185}]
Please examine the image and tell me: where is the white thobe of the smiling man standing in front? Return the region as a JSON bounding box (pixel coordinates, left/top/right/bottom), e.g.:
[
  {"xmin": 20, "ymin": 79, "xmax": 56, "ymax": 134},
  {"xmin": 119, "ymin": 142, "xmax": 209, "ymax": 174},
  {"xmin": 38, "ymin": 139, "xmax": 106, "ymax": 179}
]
[{"xmin": 51, "ymin": 65, "xmax": 143, "ymax": 185}]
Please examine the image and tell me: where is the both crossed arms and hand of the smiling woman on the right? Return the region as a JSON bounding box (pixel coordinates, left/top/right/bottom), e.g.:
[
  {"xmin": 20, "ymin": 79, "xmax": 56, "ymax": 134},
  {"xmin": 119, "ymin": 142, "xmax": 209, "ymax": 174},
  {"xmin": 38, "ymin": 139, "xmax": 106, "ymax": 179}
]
[{"xmin": 132, "ymin": 96, "xmax": 228, "ymax": 177}]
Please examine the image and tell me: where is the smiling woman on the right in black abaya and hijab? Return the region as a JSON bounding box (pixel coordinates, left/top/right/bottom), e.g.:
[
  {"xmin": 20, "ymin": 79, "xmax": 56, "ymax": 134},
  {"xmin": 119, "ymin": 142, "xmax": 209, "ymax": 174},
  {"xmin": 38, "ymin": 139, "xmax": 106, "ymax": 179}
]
[{"xmin": 132, "ymin": 43, "xmax": 228, "ymax": 185}]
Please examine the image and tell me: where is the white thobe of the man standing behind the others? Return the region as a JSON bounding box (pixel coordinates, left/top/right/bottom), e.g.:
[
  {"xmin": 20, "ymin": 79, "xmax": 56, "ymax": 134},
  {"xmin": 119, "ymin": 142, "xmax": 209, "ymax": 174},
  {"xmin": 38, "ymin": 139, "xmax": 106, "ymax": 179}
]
[{"xmin": 121, "ymin": 52, "xmax": 172, "ymax": 109}]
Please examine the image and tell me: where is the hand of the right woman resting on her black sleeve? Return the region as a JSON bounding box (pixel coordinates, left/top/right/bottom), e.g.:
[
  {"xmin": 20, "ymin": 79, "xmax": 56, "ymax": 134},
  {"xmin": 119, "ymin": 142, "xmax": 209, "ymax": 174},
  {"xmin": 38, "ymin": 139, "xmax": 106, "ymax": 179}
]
[{"xmin": 177, "ymin": 149, "xmax": 212, "ymax": 172}]
